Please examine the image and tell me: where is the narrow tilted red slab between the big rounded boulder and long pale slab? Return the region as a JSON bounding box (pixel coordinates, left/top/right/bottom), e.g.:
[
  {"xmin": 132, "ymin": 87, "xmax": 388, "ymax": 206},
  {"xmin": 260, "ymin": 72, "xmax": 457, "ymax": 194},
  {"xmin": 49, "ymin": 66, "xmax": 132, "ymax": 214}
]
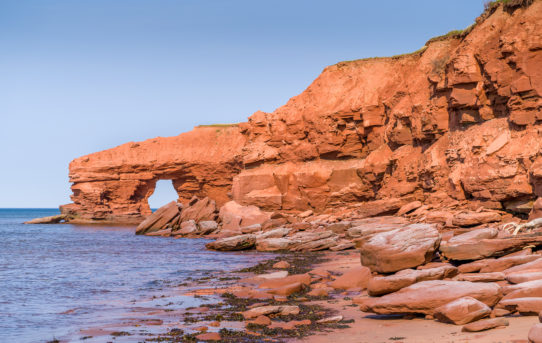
[{"xmin": 367, "ymin": 266, "xmax": 457, "ymax": 296}]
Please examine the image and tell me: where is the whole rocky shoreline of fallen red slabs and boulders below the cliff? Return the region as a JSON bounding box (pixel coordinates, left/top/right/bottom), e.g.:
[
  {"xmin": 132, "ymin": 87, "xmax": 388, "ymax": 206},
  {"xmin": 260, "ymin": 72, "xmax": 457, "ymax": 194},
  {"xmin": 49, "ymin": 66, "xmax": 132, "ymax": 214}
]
[{"xmin": 36, "ymin": 198, "xmax": 542, "ymax": 342}]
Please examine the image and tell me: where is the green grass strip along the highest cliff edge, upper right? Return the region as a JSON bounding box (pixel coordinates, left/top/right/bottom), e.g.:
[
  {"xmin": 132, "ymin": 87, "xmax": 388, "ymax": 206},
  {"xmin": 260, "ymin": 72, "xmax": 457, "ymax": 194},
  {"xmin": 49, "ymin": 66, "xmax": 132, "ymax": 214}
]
[{"xmin": 335, "ymin": 0, "xmax": 536, "ymax": 67}]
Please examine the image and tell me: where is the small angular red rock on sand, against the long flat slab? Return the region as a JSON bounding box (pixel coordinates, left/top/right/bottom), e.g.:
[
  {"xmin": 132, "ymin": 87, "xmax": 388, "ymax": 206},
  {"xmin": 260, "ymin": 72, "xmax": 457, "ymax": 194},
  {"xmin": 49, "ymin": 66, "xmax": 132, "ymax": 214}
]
[{"xmin": 434, "ymin": 297, "xmax": 491, "ymax": 325}]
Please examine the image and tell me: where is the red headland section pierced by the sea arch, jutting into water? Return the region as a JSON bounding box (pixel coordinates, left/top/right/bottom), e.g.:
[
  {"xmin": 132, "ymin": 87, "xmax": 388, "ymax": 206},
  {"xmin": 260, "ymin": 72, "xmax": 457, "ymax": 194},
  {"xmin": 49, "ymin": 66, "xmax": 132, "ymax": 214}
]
[{"xmin": 61, "ymin": 126, "xmax": 245, "ymax": 223}]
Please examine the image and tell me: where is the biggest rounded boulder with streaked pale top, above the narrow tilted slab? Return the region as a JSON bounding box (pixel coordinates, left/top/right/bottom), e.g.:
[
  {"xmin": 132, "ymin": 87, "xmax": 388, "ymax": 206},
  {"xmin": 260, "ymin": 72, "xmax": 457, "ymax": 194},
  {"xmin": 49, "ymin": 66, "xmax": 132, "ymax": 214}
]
[{"xmin": 358, "ymin": 224, "xmax": 440, "ymax": 273}]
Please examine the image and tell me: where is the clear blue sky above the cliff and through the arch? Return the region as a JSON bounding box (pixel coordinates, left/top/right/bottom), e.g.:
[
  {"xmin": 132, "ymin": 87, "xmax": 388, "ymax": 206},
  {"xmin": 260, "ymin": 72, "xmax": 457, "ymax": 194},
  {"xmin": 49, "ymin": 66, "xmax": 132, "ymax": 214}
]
[{"xmin": 0, "ymin": 0, "xmax": 484, "ymax": 207}]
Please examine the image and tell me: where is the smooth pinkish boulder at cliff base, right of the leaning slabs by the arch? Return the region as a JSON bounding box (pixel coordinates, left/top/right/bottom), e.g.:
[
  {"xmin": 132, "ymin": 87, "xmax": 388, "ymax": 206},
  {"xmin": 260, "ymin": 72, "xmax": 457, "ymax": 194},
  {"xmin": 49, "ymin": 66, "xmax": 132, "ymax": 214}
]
[{"xmin": 219, "ymin": 201, "xmax": 271, "ymax": 232}]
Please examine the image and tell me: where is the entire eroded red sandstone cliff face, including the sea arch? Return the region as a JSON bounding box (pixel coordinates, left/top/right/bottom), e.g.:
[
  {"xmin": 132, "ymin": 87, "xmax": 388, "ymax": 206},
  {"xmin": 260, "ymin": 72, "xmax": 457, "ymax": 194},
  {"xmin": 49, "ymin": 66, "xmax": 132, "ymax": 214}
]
[{"xmin": 64, "ymin": 1, "xmax": 542, "ymax": 221}]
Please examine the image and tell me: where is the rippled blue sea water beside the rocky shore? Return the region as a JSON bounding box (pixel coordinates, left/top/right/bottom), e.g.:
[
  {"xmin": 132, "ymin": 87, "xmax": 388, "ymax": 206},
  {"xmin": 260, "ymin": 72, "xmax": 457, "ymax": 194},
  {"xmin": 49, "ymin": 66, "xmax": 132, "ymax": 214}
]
[{"xmin": 0, "ymin": 209, "xmax": 269, "ymax": 343}]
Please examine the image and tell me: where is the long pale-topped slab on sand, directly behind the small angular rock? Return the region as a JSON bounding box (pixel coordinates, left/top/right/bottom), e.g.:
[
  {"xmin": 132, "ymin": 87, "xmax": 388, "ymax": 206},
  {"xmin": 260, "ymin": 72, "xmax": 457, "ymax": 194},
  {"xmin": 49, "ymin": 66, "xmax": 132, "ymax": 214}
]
[{"xmin": 358, "ymin": 280, "xmax": 502, "ymax": 315}]
